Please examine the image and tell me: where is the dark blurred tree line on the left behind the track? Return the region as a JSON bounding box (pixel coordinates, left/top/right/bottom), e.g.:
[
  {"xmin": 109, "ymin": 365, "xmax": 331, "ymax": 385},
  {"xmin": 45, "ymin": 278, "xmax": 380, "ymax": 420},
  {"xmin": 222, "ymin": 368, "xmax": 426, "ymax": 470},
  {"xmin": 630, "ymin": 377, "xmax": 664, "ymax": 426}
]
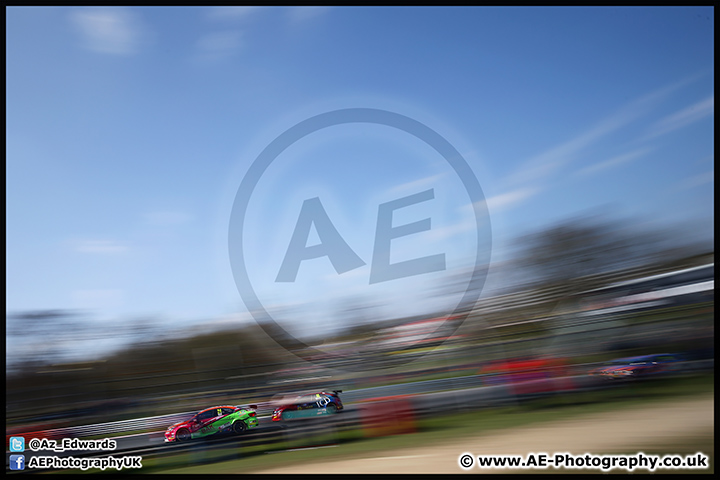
[{"xmin": 6, "ymin": 311, "xmax": 293, "ymax": 421}]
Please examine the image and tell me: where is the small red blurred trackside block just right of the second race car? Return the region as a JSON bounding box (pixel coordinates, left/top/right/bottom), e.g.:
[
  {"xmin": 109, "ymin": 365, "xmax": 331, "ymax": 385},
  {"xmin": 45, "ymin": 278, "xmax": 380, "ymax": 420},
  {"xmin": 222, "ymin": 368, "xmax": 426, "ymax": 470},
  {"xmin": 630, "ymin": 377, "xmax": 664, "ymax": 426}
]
[{"xmin": 360, "ymin": 395, "xmax": 417, "ymax": 437}]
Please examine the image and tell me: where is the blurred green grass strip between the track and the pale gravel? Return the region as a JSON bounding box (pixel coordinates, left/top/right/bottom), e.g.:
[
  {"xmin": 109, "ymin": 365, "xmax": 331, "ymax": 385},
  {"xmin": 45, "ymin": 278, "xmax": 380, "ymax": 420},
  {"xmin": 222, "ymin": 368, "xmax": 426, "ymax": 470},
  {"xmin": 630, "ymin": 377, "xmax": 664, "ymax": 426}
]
[{"xmin": 143, "ymin": 374, "xmax": 714, "ymax": 474}]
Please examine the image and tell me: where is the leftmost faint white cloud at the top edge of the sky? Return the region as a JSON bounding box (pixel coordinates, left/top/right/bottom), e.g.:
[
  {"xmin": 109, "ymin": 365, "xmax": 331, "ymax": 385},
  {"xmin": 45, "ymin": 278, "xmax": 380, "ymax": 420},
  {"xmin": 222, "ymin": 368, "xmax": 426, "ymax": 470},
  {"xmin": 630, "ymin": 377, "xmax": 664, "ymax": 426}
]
[{"xmin": 70, "ymin": 7, "xmax": 143, "ymax": 55}]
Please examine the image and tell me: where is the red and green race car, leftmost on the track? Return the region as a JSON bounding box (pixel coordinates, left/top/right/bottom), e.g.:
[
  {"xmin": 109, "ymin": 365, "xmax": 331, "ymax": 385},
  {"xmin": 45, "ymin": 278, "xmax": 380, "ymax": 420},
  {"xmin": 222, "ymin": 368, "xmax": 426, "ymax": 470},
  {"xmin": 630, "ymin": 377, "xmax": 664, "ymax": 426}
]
[{"xmin": 165, "ymin": 405, "xmax": 258, "ymax": 442}]
